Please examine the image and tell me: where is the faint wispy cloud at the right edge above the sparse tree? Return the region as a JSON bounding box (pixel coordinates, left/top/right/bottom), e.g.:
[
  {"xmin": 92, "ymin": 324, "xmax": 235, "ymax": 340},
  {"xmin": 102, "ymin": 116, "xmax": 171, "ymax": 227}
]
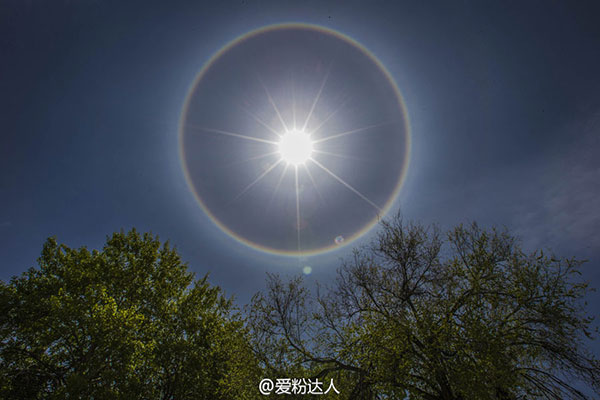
[{"xmin": 514, "ymin": 108, "xmax": 600, "ymax": 255}]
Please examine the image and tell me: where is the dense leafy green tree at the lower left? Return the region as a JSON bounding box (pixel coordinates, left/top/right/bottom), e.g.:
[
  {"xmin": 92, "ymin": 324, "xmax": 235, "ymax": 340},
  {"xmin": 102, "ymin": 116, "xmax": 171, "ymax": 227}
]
[{"xmin": 0, "ymin": 230, "xmax": 258, "ymax": 400}]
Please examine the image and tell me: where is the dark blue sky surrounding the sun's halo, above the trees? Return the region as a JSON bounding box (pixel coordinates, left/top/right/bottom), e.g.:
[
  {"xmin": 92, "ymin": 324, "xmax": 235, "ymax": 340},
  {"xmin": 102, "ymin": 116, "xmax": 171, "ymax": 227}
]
[{"xmin": 0, "ymin": 0, "xmax": 600, "ymax": 356}]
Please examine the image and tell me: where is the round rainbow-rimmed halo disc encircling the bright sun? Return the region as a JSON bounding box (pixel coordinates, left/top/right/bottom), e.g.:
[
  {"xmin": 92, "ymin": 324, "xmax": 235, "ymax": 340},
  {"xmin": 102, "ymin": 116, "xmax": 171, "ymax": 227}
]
[{"xmin": 179, "ymin": 23, "xmax": 410, "ymax": 256}]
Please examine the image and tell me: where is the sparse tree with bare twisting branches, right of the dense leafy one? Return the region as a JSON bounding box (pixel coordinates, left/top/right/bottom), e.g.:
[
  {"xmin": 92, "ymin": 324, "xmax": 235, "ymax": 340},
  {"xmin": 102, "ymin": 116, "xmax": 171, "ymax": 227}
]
[{"xmin": 250, "ymin": 216, "xmax": 600, "ymax": 400}]
